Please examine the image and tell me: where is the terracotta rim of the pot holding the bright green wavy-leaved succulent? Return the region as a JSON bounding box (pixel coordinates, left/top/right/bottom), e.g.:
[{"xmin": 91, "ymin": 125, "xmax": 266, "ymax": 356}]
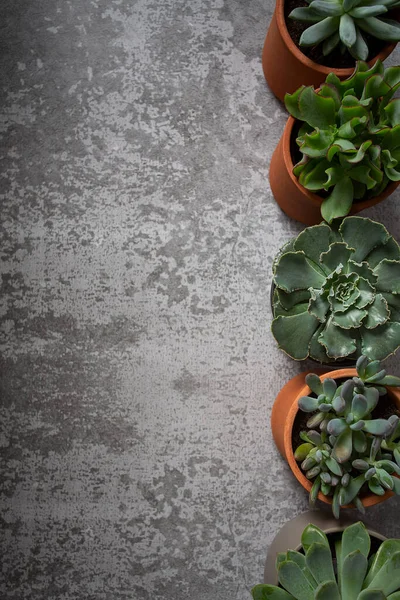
[{"xmin": 278, "ymin": 116, "xmax": 400, "ymax": 212}]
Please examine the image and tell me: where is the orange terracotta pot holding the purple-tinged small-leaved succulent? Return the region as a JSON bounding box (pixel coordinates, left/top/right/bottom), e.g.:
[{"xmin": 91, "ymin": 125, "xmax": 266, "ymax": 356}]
[{"xmin": 271, "ymin": 369, "xmax": 400, "ymax": 508}]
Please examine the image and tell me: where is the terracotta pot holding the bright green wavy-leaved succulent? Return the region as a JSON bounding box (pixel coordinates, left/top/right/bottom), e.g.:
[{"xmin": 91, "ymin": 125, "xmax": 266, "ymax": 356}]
[{"xmin": 269, "ymin": 117, "xmax": 400, "ymax": 225}]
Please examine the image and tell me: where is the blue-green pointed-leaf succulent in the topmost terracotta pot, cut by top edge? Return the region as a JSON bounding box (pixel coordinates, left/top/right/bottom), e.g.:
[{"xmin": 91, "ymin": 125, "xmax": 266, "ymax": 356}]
[{"xmin": 289, "ymin": 0, "xmax": 400, "ymax": 60}]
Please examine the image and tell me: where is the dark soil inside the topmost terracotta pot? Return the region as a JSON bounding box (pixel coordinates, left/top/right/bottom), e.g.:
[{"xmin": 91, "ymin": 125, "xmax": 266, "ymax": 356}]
[{"xmin": 284, "ymin": 0, "xmax": 393, "ymax": 69}]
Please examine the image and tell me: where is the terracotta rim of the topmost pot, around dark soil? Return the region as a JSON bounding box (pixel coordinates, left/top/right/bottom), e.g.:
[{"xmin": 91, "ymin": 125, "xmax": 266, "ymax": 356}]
[{"xmin": 275, "ymin": 0, "xmax": 396, "ymax": 78}]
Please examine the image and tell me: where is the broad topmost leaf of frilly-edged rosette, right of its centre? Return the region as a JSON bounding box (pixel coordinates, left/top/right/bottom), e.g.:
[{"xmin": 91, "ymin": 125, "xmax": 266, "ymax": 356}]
[{"xmin": 339, "ymin": 217, "xmax": 390, "ymax": 262}]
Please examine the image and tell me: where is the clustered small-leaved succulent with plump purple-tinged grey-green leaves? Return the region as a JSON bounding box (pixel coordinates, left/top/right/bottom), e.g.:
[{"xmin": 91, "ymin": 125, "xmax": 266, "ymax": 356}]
[{"xmin": 294, "ymin": 356, "xmax": 400, "ymax": 518}]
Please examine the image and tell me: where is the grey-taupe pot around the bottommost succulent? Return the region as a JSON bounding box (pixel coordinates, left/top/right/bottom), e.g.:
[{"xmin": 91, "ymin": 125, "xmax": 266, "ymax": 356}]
[{"xmin": 264, "ymin": 510, "xmax": 386, "ymax": 585}]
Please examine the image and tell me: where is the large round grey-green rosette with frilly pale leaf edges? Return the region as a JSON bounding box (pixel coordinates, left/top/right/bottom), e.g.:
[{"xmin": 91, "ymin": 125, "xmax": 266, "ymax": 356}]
[{"xmin": 272, "ymin": 217, "xmax": 400, "ymax": 363}]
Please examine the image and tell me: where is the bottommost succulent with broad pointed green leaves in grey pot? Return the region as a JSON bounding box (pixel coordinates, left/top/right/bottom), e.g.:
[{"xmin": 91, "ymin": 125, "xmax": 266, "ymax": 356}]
[{"xmin": 251, "ymin": 522, "xmax": 400, "ymax": 600}]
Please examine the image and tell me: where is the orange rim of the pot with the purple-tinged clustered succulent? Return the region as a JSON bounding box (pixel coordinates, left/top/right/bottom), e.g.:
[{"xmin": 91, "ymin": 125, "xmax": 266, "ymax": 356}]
[{"xmin": 283, "ymin": 368, "xmax": 394, "ymax": 508}]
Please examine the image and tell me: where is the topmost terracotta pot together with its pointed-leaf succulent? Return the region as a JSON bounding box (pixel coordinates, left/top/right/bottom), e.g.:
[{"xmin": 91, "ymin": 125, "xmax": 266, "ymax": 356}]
[{"xmin": 262, "ymin": 0, "xmax": 398, "ymax": 100}]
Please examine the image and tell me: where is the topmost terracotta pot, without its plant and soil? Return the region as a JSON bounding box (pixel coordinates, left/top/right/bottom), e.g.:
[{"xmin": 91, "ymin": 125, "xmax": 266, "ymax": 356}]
[{"xmin": 262, "ymin": 0, "xmax": 396, "ymax": 101}]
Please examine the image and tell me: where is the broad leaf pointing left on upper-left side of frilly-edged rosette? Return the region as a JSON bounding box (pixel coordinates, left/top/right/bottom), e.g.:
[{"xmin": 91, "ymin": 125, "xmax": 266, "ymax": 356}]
[{"xmin": 274, "ymin": 252, "xmax": 325, "ymax": 292}]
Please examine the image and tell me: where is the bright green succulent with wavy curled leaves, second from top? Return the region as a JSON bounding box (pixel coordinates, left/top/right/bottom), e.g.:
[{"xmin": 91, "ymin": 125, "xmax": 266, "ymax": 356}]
[{"xmin": 285, "ymin": 60, "xmax": 400, "ymax": 223}]
